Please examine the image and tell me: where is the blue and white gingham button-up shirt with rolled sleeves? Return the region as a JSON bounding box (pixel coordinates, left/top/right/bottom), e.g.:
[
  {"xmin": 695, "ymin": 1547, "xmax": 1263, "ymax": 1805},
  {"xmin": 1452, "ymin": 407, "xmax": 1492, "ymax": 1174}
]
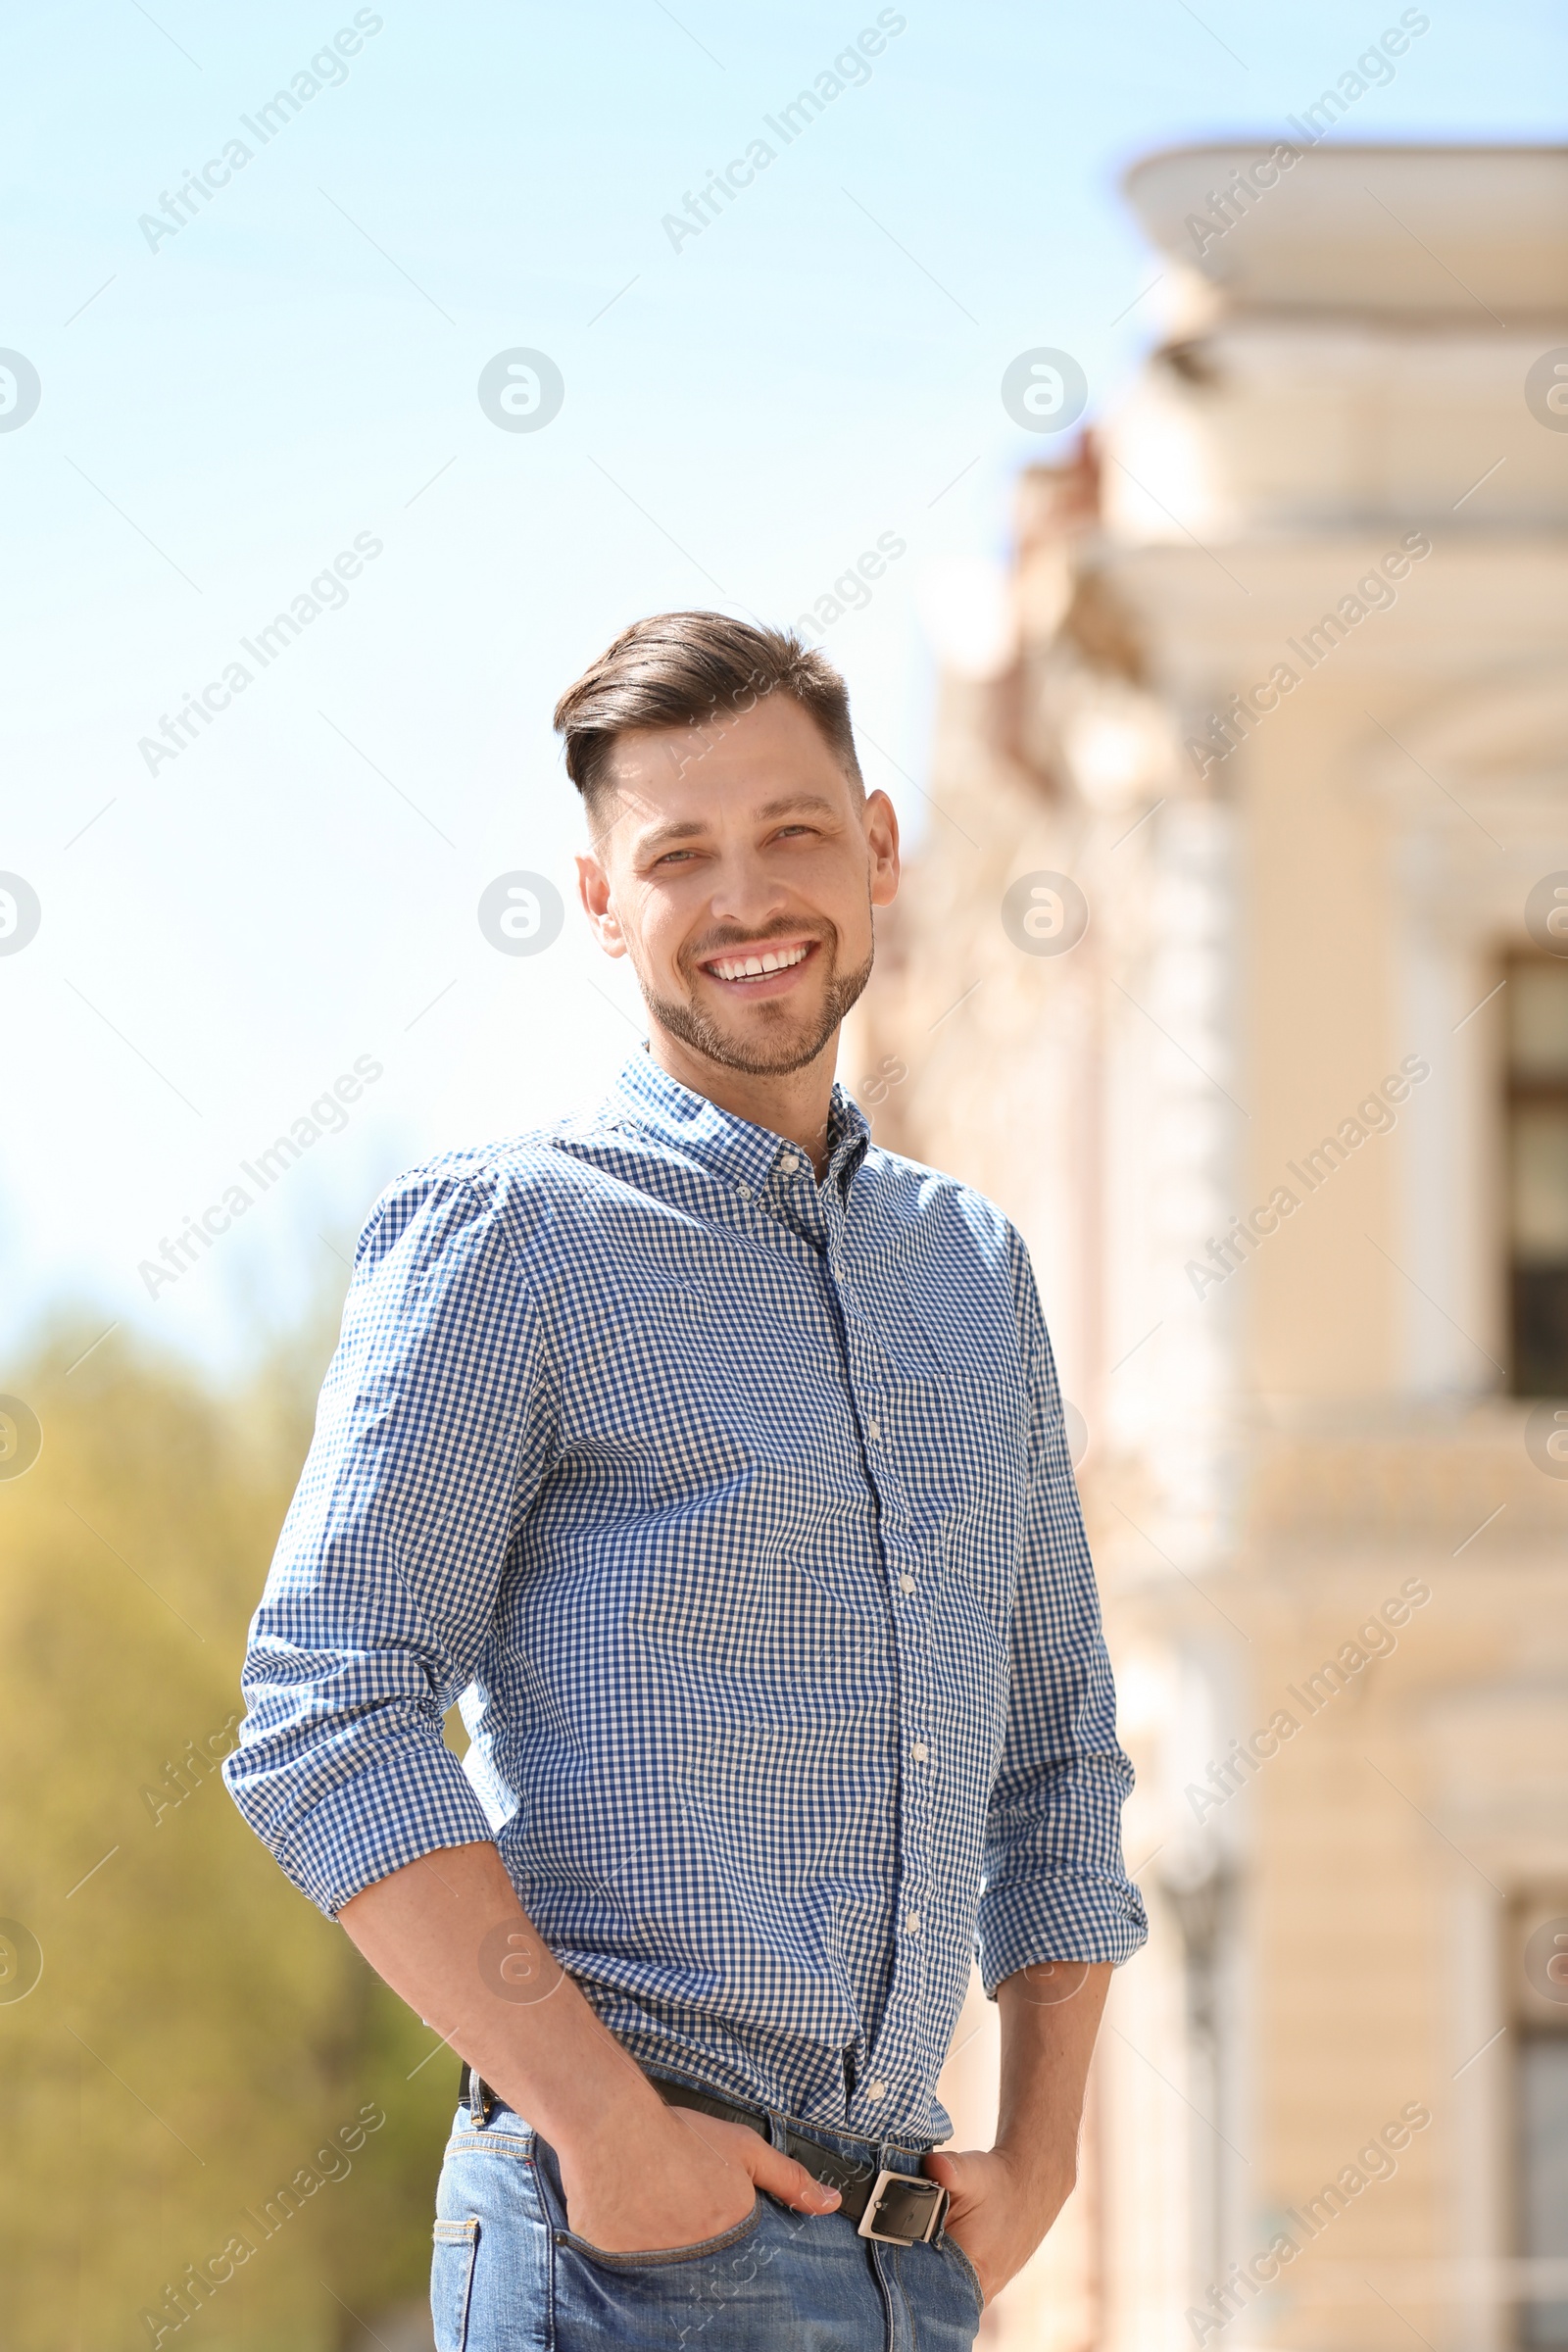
[{"xmin": 225, "ymin": 1049, "xmax": 1145, "ymax": 2138}]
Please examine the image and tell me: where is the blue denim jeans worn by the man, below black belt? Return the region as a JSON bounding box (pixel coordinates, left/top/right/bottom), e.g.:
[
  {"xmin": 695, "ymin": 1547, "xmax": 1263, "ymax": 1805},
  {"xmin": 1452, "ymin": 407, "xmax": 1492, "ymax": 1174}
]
[{"xmin": 430, "ymin": 2105, "xmax": 980, "ymax": 2352}]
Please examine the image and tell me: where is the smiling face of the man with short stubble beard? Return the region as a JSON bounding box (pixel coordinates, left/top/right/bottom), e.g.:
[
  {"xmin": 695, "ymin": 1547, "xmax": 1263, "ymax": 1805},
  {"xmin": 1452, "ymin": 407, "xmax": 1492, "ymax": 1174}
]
[{"xmin": 578, "ymin": 694, "xmax": 898, "ymax": 1077}]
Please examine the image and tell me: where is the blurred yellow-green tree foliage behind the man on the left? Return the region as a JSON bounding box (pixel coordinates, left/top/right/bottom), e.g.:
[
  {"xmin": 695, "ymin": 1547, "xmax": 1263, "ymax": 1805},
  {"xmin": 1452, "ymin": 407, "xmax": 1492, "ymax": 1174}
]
[{"xmin": 0, "ymin": 1324, "xmax": 456, "ymax": 2352}]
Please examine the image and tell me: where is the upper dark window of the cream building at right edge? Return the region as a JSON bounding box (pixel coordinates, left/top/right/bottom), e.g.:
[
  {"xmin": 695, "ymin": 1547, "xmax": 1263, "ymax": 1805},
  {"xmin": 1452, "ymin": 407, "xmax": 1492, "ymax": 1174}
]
[{"xmin": 1502, "ymin": 957, "xmax": 1568, "ymax": 1392}]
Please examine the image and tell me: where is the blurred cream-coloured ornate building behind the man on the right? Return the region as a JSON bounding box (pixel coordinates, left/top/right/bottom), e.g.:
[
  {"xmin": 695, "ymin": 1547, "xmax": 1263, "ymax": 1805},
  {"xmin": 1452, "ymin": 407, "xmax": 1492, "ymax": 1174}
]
[{"xmin": 869, "ymin": 141, "xmax": 1568, "ymax": 2352}]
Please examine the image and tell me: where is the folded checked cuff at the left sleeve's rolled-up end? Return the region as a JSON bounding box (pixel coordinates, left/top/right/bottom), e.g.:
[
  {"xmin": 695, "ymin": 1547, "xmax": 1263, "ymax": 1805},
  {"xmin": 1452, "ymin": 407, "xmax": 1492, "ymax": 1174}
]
[{"xmin": 250, "ymin": 1742, "xmax": 496, "ymax": 1919}]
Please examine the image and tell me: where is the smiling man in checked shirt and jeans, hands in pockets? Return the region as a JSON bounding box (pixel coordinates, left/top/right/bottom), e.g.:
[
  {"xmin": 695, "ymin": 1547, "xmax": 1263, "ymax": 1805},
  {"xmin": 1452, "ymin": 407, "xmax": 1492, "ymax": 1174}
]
[{"xmin": 225, "ymin": 612, "xmax": 1143, "ymax": 2352}]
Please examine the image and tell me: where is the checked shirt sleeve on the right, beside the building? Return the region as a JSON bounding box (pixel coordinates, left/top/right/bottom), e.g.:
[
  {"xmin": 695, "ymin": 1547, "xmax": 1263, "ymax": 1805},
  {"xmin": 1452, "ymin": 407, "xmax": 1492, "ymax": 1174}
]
[{"xmin": 976, "ymin": 1237, "xmax": 1148, "ymax": 1994}]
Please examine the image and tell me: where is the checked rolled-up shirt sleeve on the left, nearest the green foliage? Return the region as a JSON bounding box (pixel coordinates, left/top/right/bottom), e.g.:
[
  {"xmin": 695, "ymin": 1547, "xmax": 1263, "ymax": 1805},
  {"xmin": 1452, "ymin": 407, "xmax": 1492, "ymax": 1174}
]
[{"xmin": 223, "ymin": 1171, "xmax": 555, "ymax": 1915}]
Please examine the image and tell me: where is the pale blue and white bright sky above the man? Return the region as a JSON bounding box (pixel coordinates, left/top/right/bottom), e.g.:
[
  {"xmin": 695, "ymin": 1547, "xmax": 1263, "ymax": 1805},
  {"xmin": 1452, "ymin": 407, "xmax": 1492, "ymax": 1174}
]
[{"xmin": 0, "ymin": 0, "xmax": 1568, "ymax": 1390}]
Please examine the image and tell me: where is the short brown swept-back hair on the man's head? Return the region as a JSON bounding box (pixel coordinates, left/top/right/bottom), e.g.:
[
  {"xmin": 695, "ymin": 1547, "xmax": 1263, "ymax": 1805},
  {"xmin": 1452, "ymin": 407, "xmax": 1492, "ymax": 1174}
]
[{"xmin": 555, "ymin": 612, "xmax": 865, "ymax": 813}]
